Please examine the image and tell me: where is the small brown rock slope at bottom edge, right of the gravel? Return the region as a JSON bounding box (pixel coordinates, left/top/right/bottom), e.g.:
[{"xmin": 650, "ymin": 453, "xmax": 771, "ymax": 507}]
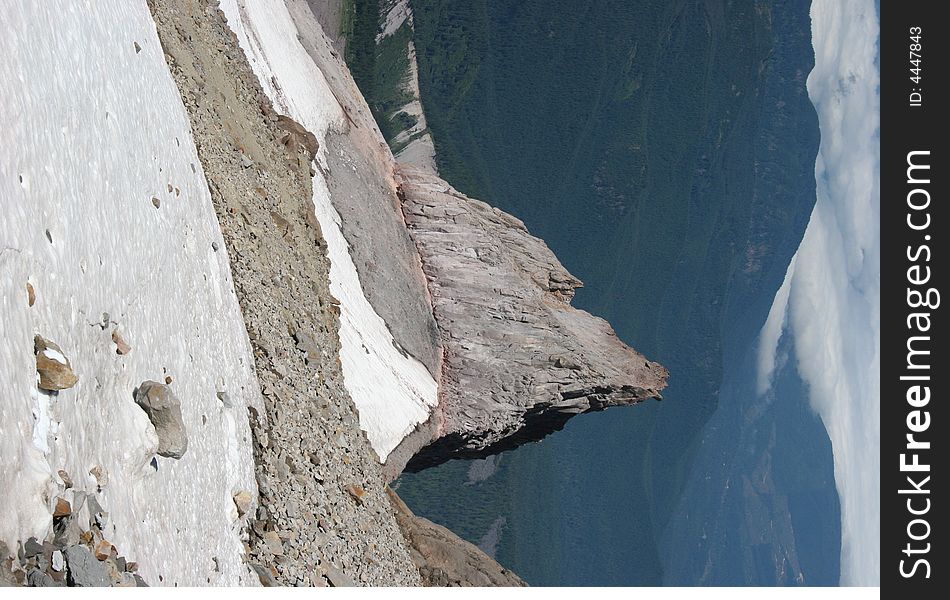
[{"xmin": 386, "ymin": 488, "xmax": 527, "ymax": 587}]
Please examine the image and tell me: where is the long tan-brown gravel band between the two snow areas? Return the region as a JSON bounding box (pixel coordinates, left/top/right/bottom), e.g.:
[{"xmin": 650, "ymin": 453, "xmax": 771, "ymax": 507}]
[{"xmin": 149, "ymin": 0, "xmax": 419, "ymax": 585}]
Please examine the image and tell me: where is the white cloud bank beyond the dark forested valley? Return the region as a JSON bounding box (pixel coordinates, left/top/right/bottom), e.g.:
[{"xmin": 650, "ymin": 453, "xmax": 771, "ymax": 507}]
[{"xmin": 758, "ymin": 0, "xmax": 881, "ymax": 585}]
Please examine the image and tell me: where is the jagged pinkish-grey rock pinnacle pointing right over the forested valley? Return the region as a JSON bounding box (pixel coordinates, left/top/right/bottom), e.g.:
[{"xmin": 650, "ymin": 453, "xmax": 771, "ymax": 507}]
[{"xmin": 397, "ymin": 166, "xmax": 667, "ymax": 471}]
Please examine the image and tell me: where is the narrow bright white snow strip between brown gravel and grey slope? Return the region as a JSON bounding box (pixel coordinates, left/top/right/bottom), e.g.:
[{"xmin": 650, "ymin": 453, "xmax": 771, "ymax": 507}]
[{"xmin": 220, "ymin": 0, "xmax": 438, "ymax": 462}]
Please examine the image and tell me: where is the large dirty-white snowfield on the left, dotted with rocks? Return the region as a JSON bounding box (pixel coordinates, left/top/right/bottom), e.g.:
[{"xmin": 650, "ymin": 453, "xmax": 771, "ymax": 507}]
[{"xmin": 0, "ymin": 0, "xmax": 260, "ymax": 585}]
